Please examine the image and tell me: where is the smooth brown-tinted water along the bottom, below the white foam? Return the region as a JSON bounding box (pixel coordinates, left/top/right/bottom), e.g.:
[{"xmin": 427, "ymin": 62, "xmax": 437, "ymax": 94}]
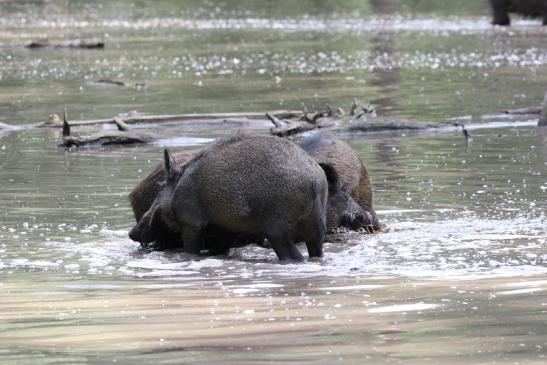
[{"xmin": 0, "ymin": 276, "xmax": 547, "ymax": 364}]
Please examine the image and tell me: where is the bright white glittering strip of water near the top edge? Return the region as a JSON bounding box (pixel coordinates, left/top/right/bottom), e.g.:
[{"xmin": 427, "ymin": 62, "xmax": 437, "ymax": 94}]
[{"xmin": 0, "ymin": 15, "xmax": 538, "ymax": 35}]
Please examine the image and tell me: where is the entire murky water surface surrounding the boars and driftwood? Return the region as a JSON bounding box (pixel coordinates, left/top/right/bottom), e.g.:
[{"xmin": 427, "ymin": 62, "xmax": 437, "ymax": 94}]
[{"xmin": 0, "ymin": 1, "xmax": 547, "ymax": 364}]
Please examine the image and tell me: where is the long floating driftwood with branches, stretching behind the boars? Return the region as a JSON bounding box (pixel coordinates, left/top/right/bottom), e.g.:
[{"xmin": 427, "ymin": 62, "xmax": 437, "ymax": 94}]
[{"xmin": 4, "ymin": 96, "xmax": 547, "ymax": 148}]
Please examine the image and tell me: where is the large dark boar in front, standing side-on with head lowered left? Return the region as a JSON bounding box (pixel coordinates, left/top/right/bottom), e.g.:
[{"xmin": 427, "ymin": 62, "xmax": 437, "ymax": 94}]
[{"xmin": 129, "ymin": 134, "xmax": 326, "ymax": 261}]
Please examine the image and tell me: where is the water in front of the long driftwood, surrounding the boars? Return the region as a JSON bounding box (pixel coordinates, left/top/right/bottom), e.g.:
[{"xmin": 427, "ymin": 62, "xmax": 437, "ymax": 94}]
[{"xmin": 0, "ymin": 127, "xmax": 547, "ymax": 364}]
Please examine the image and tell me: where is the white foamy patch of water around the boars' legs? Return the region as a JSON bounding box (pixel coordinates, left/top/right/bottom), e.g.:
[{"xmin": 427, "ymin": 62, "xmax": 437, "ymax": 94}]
[{"xmin": 0, "ymin": 209, "xmax": 547, "ymax": 280}]
